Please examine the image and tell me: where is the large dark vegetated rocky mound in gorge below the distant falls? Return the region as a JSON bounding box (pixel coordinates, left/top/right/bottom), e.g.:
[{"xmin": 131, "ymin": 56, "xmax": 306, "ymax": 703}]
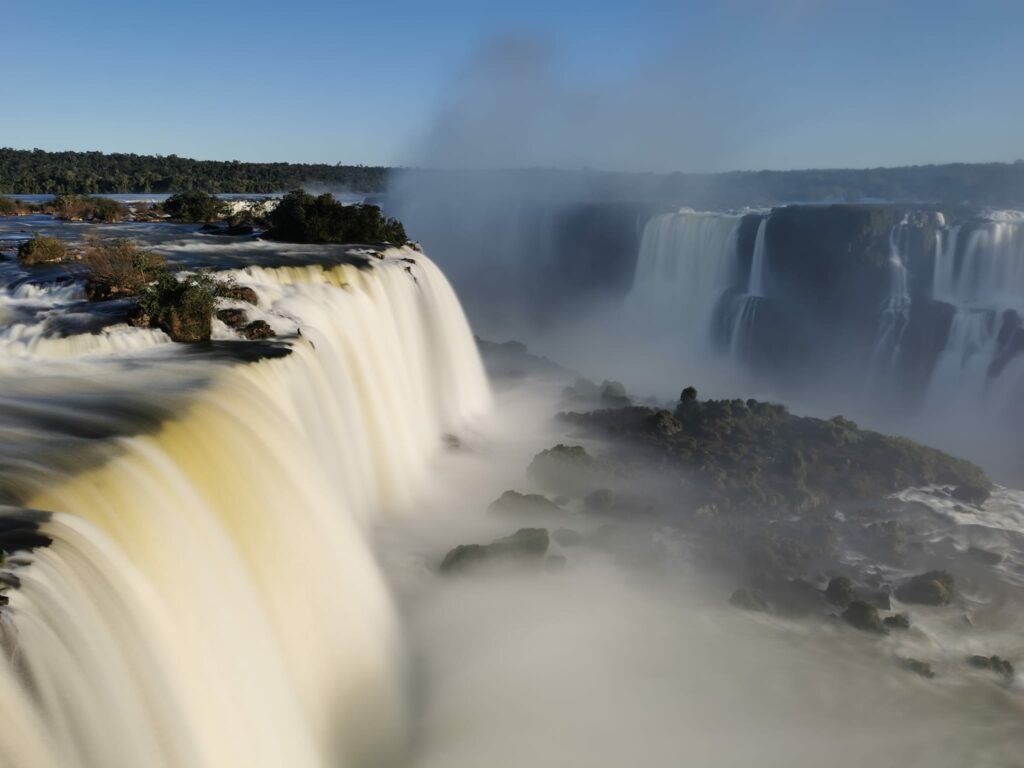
[{"xmin": 557, "ymin": 399, "xmax": 990, "ymax": 512}]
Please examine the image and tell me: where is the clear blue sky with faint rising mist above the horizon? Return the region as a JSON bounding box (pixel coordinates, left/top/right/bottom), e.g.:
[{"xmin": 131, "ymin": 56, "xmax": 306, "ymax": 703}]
[{"xmin": 0, "ymin": 0, "xmax": 1024, "ymax": 171}]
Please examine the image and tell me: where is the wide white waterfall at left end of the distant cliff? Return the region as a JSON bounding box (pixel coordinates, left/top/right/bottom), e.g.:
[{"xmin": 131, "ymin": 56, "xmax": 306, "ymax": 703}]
[{"xmin": 626, "ymin": 211, "xmax": 742, "ymax": 345}]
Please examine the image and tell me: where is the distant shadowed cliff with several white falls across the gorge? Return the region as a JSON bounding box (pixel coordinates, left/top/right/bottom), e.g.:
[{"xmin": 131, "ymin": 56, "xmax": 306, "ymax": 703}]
[{"xmin": 623, "ymin": 206, "xmax": 1024, "ymax": 479}]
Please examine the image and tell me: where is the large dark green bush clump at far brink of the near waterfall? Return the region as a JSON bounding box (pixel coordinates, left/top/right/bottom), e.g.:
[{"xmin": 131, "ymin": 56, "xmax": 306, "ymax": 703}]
[{"xmin": 266, "ymin": 189, "xmax": 409, "ymax": 245}]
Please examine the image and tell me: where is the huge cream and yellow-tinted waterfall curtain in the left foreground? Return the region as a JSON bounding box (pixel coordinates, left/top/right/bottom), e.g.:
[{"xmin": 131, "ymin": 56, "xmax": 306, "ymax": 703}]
[{"xmin": 0, "ymin": 251, "xmax": 489, "ymax": 768}]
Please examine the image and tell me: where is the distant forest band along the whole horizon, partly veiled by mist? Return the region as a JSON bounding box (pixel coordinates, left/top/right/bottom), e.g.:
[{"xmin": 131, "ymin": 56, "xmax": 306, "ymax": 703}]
[{"xmin": 0, "ymin": 148, "xmax": 1024, "ymax": 209}]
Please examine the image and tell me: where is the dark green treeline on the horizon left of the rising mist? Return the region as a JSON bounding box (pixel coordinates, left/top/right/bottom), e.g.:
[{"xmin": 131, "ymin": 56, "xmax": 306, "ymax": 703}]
[{"xmin": 0, "ymin": 148, "xmax": 388, "ymax": 195}]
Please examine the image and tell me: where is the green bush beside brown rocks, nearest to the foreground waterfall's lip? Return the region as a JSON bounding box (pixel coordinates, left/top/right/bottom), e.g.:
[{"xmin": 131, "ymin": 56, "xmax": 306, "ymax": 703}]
[{"xmin": 139, "ymin": 270, "xmax": 218, "ymax": 341}]
